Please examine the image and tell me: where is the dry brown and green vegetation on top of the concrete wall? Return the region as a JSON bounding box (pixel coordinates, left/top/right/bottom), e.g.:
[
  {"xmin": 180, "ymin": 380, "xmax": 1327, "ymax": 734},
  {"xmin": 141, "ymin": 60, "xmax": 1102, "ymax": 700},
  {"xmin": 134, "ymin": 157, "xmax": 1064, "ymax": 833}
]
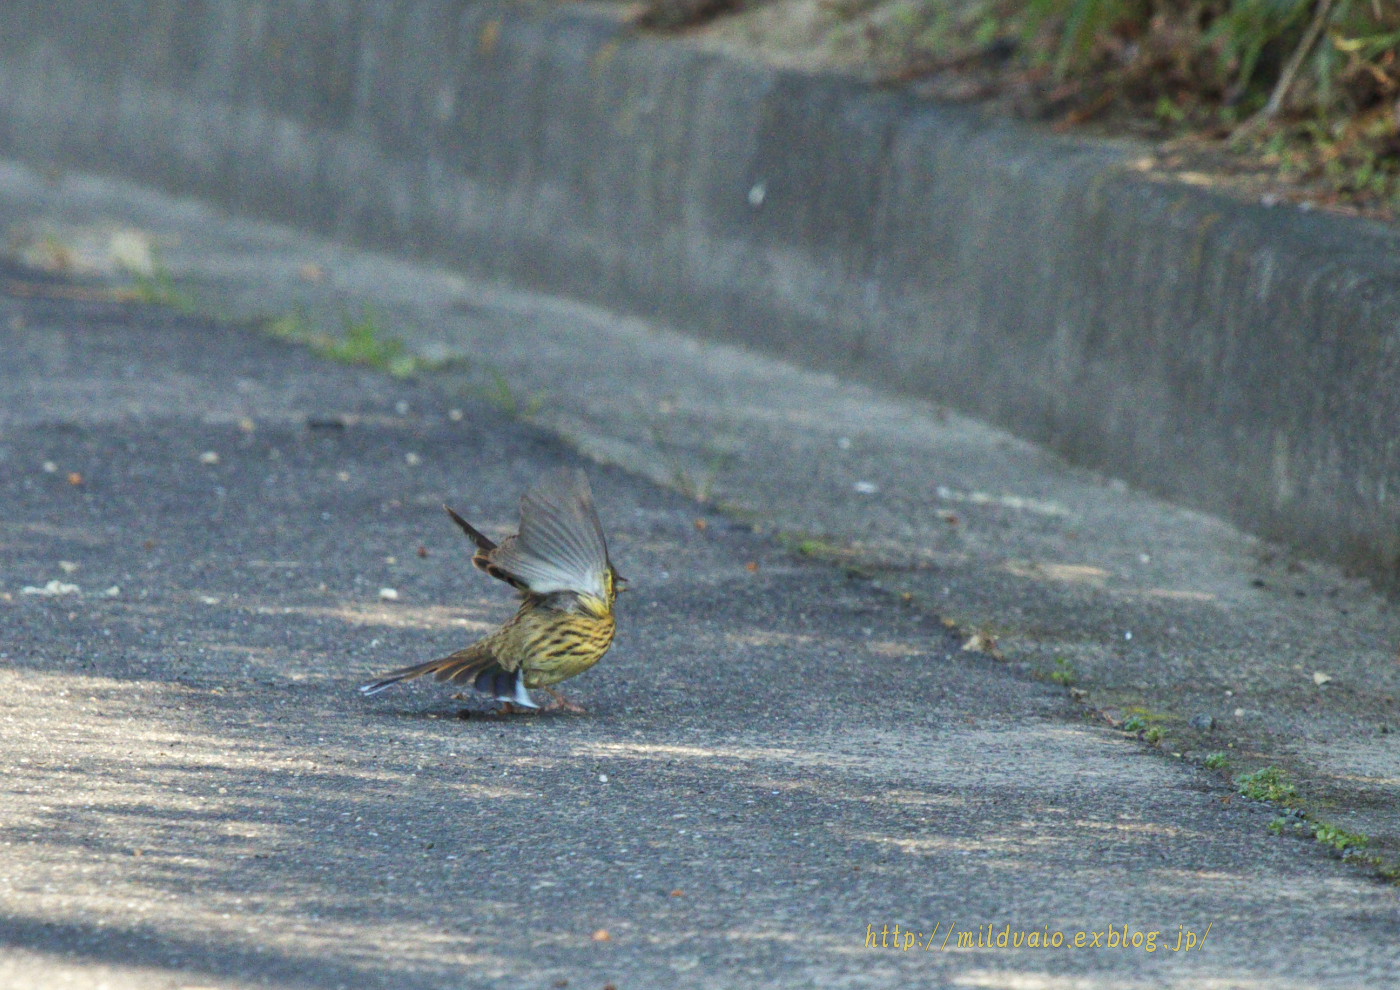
[{"xmin": 647, "ymin": 0, "xmax": 1400, "ymax": 218}]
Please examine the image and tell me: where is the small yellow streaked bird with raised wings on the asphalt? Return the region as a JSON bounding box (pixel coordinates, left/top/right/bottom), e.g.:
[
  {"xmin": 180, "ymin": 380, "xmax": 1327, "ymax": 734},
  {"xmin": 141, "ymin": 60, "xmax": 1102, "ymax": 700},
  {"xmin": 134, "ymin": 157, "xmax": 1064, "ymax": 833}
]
[{"xmin": 360, "ymin": 469, "xmax": 626, "ymax": 711}]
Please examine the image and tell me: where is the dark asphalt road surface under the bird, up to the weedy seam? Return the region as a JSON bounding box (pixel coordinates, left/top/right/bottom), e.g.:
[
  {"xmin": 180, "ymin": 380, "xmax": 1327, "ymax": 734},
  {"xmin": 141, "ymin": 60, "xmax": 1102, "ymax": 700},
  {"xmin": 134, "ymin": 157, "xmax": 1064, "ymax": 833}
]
[{"xmin": 0, "ymin": 174, "xmax": 1400, "ymax": 990}]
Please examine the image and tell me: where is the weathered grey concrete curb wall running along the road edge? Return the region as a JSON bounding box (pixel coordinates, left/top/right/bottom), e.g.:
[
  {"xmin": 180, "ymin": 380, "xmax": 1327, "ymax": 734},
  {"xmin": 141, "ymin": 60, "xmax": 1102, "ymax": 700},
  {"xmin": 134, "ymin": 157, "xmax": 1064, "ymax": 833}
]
[{"xmin": 0, "ymin": 0, "xmax": 1400, "ymax": 588}]
